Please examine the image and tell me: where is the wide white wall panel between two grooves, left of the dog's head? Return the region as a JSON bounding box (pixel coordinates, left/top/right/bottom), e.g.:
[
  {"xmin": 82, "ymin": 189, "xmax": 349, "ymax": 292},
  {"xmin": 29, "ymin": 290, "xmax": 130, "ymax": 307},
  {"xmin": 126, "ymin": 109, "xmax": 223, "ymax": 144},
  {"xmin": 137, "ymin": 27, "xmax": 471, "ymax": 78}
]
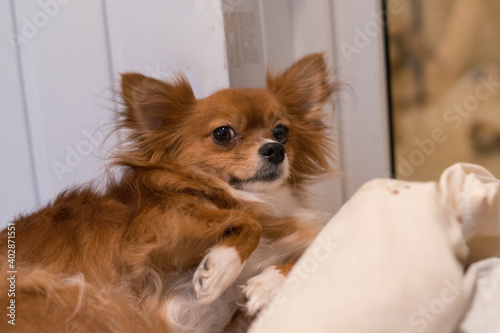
[{"xmin": 15, "ymin": 0, "xmax": 117, "ymax": 201}]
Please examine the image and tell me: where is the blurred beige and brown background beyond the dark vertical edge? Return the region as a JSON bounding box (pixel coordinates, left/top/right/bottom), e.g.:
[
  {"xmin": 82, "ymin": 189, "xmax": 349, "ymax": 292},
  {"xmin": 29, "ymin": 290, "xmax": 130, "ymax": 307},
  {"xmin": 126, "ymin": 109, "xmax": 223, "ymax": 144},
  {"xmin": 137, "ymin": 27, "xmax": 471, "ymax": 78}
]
[{"xmin": 386, "ymin": 0, "xmax": 500, "ymax": 181}]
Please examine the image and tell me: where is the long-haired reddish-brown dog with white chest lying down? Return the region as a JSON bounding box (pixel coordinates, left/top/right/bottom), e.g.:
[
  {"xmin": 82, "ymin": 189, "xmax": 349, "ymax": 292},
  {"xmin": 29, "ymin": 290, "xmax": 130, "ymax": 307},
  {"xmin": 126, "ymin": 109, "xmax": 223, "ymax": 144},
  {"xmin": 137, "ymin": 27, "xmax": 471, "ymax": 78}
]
[{"xmin": 0, "ymin": 54, "xmax": 333, "ymax": 332}]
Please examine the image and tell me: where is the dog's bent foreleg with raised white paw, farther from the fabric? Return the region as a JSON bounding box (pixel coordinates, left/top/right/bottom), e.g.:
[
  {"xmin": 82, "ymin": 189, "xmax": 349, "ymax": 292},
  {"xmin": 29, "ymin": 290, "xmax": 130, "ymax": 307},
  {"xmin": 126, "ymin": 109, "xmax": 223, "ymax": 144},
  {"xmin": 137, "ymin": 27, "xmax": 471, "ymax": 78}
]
[{"xmin": 193, "ymin": 212, "xmax": 262, "ymax": 303}]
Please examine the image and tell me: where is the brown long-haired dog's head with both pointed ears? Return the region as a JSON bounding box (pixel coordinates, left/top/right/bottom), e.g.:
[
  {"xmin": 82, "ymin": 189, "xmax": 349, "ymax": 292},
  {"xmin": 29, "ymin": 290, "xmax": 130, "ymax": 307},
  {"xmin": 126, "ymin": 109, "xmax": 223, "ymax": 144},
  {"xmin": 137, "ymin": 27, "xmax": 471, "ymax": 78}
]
[{"xmin": 121, "ymin": 54, "xmax": 333, "ymax": 191}]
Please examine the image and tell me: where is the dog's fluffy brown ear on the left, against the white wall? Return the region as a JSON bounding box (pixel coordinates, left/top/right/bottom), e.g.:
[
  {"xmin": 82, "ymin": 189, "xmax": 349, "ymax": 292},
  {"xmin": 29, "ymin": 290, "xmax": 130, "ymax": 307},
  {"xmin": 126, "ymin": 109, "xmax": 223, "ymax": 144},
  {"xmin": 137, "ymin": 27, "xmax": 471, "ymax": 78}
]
[{"xmin": 121, "ymin": 73, "xmax": 196, "ymax": 134}]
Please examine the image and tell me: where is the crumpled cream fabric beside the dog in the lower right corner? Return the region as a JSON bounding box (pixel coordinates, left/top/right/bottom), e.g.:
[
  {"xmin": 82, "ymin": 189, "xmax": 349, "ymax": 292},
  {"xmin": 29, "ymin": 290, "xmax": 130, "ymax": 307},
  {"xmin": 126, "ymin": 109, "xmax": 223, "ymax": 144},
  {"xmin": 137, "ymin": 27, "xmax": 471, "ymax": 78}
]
[{"xmin": 250, "ymin": 164, "xmax": 500, "ymax": 333}]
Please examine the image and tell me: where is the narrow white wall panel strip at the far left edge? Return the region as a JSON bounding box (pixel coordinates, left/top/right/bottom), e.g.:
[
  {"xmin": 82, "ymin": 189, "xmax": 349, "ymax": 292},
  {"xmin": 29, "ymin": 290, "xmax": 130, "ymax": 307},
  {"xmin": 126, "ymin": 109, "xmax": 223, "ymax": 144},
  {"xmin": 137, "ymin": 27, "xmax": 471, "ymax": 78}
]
[{"xmin": 0, "ymin": 1, "xmax": 37, "ymax": 229}]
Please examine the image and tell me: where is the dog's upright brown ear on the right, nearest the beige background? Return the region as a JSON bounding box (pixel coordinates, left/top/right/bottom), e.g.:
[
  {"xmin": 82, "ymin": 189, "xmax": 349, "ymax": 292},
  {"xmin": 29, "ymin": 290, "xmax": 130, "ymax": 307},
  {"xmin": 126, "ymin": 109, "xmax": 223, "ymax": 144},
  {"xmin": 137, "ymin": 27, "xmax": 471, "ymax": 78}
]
[{"xmin": 266, "ymin": 53, "xmax": 334, "ymax": 120}]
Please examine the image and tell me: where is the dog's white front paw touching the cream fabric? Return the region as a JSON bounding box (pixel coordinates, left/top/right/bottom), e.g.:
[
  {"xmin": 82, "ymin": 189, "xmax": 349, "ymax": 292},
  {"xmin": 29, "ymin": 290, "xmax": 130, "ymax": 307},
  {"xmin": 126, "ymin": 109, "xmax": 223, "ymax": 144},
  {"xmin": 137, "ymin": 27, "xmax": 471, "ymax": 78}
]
[{"xmin": 243, "ymin": 266, "xmax": 285, "ymax": 316}]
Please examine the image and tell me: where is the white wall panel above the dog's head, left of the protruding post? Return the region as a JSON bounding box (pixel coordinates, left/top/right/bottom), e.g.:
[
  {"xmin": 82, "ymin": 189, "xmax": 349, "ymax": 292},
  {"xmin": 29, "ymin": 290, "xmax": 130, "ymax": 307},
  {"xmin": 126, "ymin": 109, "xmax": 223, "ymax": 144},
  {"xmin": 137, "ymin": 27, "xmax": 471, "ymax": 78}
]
[{"xmin": 106, "ymin": 0, "xmax": 229, "ymax": 97}]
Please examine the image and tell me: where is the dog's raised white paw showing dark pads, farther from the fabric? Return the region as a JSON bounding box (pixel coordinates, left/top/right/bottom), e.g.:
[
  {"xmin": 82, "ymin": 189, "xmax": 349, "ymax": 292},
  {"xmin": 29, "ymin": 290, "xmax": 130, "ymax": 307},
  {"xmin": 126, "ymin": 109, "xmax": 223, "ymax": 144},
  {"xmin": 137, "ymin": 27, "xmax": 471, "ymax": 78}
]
[{"xmin": 193, "ymin": 246, "xmax": 244, "ymax": 304}]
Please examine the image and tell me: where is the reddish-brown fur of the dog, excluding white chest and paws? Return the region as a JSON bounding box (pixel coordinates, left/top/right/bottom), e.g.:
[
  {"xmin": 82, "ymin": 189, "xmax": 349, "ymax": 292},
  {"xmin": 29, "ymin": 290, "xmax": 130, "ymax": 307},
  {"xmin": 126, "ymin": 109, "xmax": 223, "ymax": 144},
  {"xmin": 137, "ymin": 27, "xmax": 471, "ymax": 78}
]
[{"xmin": 0, "ymin": 54, "xmax": 332, "ymax": 332}]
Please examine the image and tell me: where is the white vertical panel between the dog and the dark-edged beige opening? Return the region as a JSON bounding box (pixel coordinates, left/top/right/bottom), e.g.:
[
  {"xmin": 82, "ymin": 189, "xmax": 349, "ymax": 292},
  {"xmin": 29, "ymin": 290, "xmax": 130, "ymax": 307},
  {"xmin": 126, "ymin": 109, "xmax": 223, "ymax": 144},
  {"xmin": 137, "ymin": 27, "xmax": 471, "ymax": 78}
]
[{"xmin": 331, "ymin": 0, "xmax": 391, "ymax": 197}]
